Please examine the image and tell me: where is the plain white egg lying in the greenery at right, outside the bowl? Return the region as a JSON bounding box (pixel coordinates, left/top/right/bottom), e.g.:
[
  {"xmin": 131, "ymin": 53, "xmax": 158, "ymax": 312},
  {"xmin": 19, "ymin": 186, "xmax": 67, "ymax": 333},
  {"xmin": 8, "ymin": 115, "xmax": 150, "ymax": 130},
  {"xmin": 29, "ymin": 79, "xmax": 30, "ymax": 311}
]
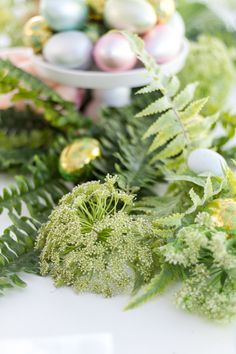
[{"xmin": 188, "ymin": 149, "xmax": 227, "ymax": 177}]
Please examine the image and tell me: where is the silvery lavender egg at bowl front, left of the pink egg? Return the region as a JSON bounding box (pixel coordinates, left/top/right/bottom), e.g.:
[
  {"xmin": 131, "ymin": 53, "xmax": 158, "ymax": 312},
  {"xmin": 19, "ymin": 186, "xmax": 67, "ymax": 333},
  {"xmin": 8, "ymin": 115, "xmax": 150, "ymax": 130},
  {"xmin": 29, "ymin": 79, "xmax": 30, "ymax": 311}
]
[{"xmin": 43, "ymin": 31, "xmax": 93, "ymax": 70}]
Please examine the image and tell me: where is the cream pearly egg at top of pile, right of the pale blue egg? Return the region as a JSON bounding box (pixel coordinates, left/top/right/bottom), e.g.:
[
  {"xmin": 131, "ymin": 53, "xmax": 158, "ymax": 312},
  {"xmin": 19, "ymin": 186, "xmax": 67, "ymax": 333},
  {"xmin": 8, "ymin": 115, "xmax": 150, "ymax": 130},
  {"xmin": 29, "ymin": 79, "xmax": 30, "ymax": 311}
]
[{"xmin": 104, "ymin": 0, "xmax": 157, "ymax": 34}]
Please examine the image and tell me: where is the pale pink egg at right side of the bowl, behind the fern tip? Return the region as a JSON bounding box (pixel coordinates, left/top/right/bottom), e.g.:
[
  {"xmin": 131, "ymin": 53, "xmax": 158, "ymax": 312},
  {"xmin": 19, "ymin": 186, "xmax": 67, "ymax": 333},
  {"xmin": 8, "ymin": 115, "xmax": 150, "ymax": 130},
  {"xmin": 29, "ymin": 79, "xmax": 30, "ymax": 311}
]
[{"xmin": 144, "ymin": 24, "xmax": 183, "ymax": 64}]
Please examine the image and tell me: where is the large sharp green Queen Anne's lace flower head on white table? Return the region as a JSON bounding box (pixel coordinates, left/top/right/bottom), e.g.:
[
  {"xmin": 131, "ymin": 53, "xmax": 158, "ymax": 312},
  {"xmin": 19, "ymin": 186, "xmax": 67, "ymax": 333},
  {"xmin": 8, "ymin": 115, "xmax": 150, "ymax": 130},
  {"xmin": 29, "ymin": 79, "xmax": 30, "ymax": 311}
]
[{"xmin": 37, "ymin": 177, "xmax": 154, "ymax": 297}]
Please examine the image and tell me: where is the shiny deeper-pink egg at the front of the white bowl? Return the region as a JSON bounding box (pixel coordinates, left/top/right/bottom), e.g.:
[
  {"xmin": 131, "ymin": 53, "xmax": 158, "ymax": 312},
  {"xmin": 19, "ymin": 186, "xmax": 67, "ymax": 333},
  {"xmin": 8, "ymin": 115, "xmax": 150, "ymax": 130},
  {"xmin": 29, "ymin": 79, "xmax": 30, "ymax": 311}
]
[{"xmin": 93, "ymin": 33, "xmax": 137, "ymax": 72}]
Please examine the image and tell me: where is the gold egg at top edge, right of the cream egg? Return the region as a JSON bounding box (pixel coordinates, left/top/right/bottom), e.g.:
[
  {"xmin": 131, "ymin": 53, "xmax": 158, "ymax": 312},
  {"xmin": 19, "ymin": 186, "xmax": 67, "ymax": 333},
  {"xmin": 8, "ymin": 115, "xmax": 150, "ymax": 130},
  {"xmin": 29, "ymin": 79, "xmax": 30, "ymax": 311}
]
[{"xmin": 149, "ymin": 0, "xmax": 176, "ymax": 23}]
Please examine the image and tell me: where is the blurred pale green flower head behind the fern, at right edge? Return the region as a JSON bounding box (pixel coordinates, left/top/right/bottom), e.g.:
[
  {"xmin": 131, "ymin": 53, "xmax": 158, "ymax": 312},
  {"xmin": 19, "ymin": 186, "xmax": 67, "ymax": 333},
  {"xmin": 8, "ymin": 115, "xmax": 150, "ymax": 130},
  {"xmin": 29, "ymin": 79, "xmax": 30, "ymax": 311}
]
[{"xmin": 179, "ymin": 36, "xmax": 235, "ymax": 114}]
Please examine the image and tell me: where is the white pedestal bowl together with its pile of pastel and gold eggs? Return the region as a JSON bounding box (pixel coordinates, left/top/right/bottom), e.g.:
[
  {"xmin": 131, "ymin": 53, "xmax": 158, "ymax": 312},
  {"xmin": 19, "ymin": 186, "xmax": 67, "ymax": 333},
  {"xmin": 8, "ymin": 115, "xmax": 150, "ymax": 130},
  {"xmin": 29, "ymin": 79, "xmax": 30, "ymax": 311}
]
[{"xmin": 24, "ymin": 0, "xmax": 188, "ymax": 106}]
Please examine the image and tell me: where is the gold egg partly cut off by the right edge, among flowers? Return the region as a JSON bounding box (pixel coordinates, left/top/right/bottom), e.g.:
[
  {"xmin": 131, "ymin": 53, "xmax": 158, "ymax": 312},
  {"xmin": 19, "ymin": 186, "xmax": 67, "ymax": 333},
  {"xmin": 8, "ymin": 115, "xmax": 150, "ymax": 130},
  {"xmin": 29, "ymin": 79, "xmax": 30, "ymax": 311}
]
[{"xmin": 206, "ymin": 198, "xmax": 236, "ymax": 234}]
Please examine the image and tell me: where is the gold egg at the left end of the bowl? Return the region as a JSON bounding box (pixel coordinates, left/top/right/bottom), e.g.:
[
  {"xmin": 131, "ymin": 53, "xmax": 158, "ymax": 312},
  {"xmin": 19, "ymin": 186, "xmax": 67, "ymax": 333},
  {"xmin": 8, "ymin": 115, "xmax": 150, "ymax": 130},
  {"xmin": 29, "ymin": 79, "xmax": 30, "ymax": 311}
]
[{"xmin": 24, "ymin": 16, "xmax": 53, "ymax": 53}]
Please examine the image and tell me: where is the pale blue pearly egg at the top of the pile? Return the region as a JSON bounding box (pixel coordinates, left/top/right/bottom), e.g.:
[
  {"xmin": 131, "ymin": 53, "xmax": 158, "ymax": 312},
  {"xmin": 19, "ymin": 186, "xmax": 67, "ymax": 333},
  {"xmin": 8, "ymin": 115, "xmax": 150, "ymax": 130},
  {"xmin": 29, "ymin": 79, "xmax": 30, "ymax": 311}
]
[{"xmin": 40, "ymin": 0, "xmax": 88, "ymax": 32}]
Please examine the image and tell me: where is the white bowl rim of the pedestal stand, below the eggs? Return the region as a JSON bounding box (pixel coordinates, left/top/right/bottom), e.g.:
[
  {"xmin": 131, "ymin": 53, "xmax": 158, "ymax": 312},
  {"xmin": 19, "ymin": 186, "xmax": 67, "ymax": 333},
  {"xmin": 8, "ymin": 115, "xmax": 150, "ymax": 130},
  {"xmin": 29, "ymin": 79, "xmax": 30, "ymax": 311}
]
[{"xmin": 33, "ymin": 39, "xmax": 189, "ymax": 90}]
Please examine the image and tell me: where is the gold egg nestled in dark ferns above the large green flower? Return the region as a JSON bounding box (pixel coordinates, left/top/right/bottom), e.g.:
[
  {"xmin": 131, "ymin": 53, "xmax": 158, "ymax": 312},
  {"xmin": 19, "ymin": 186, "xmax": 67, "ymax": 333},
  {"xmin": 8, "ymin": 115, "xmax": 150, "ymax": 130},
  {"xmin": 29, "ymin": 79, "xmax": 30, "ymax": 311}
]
[{"xmin": 59, "ymin": 138, "xmax": 101, "ymax": 180}]
